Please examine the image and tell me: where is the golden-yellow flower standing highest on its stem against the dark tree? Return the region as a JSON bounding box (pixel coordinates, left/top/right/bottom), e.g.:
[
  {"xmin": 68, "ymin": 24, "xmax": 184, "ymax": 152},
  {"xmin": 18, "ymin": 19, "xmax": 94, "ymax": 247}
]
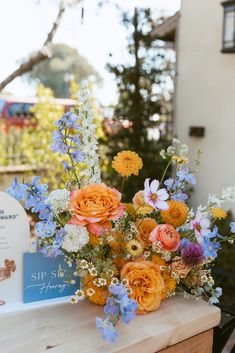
[{"xmin": 112, "ymin": 151, "xmax": 143, "ymax": 177}]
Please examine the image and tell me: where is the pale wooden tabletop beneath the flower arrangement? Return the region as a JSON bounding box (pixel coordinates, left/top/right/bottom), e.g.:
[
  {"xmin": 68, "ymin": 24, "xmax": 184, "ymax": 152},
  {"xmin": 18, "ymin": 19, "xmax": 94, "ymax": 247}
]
[{"xmin": 0, "ymin": 295, "xmax": 220, "ymax": 353}]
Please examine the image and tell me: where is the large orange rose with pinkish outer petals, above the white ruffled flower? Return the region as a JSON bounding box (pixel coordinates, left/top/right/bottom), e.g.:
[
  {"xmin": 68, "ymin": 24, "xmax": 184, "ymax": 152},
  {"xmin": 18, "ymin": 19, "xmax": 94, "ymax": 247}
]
[{"xmin": 70, "ymin": 184, "xmax": 125, "ymax": 236}]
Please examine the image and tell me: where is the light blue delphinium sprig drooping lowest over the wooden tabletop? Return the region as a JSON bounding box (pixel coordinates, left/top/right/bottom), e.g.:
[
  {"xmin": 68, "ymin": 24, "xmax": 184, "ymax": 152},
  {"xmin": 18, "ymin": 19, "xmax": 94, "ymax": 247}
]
[{"xmin": 96, "ymin": 283, "xmax": 138, "ymax": 342}]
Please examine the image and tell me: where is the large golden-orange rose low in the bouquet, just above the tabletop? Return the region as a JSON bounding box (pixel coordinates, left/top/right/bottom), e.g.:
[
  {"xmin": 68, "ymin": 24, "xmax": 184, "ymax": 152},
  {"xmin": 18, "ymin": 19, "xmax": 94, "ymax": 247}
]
[{"xmin": 121, "ymin": 261, "xmax": 164, "ymax": 314}]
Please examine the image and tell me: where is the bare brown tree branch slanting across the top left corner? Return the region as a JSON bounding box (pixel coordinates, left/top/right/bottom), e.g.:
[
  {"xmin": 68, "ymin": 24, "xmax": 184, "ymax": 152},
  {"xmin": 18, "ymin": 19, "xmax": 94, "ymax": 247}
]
[{"xmin": 0, "ymin": 0, "xmax": 65, "ymax": 92}]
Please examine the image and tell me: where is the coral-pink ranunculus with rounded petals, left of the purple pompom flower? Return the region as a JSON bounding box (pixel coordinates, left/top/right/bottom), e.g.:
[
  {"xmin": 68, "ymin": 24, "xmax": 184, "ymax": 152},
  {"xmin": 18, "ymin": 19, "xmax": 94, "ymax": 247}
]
[{"xmin": 149, "ymin": 224, "xmax": 180, "ymax": 251}]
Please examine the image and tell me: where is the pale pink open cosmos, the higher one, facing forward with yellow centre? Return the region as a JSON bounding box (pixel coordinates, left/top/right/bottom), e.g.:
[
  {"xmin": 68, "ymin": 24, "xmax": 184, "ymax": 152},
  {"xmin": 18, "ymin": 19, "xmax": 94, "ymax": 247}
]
[{"xmin": 144, "ymin": 178, "xmax": 169, "ymax": 210}]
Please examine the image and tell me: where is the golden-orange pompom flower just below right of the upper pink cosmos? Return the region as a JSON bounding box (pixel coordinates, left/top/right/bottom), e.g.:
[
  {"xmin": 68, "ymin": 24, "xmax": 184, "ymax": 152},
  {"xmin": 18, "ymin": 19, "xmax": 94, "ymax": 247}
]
[{"xmin": 161, "ymin": 200, "xmax": 188, "ymax": 228}]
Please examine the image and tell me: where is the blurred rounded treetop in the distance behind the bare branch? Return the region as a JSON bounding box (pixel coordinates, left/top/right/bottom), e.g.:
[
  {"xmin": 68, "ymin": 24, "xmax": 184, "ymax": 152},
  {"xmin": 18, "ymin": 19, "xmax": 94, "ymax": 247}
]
[{"xmin": 28, "ymin": 43, "xmax": 100, "ymax": 98}]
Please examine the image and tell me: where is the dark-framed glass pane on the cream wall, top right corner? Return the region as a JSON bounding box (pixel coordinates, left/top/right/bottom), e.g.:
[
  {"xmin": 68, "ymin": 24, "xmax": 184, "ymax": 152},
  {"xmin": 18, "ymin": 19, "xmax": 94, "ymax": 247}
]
[{"xmin": 222, "ymin": 0, "xmax": 235, "ymax": 53}]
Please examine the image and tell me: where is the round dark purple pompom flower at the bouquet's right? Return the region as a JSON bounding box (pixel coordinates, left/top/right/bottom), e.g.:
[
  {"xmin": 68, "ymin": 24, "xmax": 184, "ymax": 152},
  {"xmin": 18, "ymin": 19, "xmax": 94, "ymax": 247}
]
[{"xmin": 181, "ymin": 243, "xmax": 204, "ymax": 267}]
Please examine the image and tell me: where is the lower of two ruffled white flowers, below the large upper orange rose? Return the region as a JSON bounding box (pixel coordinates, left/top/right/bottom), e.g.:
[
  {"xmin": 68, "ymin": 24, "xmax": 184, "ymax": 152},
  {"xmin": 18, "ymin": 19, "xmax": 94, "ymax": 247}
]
[{"xmin": 62, "ymin": 224, "xmax": 89, "ymax": 252}]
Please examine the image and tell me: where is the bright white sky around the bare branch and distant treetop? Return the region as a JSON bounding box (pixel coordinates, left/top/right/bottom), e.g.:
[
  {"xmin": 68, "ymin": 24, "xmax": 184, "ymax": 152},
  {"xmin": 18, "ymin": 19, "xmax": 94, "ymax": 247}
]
[{"xmin": 0, "ymin": 0, "xmax": 180, "ymax": 105}]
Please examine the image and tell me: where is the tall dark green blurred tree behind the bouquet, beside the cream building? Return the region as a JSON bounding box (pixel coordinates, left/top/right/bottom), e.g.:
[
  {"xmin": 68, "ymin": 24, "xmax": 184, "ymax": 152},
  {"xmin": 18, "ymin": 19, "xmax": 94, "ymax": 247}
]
[{"xmin": 104, "ymin": 9, "xmax": 174, "ymax": 196}]
